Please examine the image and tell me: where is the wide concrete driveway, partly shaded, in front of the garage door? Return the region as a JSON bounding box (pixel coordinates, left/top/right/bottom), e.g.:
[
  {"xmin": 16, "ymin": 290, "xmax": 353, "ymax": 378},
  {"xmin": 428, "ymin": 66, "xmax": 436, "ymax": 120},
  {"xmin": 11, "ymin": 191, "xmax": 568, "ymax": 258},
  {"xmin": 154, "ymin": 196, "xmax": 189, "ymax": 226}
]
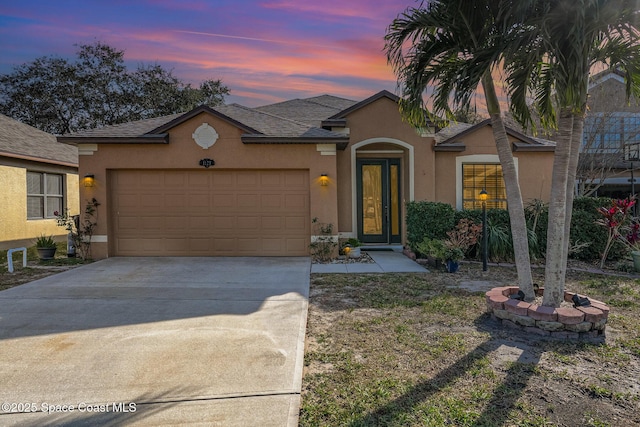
[{"xmin": 0, "ymin": 257, "xmax": 310, "ymax": 427}]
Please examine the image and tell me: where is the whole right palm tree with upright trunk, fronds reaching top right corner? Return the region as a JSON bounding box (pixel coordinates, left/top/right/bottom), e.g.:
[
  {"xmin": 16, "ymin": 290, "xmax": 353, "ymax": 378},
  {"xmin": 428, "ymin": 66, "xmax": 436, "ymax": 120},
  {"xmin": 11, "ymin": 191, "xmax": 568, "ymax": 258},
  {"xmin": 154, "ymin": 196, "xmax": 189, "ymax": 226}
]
[{"xmin": 507, "ymin": 0, "xmax": 640, "ymax": 307}]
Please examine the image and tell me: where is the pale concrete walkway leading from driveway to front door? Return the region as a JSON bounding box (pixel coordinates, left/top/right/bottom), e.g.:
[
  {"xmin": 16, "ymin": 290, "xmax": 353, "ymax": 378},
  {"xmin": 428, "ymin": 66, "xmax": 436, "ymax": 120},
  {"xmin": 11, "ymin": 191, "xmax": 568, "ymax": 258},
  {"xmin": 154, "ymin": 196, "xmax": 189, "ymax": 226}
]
[{"xmin": 311, "ymin": 251, "xmax": 429, "ymax": 273}]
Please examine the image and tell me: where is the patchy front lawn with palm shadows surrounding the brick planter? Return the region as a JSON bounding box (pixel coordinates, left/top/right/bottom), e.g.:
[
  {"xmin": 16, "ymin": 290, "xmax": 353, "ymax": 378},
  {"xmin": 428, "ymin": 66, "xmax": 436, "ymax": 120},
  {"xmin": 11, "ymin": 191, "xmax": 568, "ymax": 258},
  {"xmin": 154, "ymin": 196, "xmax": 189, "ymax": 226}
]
[{"xmin": 300, "ymin": 264, "xmax": 640, "ymax": 426}]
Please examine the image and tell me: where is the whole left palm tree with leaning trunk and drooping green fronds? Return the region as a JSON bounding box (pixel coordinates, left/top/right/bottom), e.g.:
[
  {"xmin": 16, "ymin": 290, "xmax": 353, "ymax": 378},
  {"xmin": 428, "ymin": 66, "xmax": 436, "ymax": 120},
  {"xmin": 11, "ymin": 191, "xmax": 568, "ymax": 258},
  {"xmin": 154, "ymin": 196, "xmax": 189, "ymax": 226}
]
[{"xmin": 385, "ymin": 0, "xmax": 535, "ymax": 301}]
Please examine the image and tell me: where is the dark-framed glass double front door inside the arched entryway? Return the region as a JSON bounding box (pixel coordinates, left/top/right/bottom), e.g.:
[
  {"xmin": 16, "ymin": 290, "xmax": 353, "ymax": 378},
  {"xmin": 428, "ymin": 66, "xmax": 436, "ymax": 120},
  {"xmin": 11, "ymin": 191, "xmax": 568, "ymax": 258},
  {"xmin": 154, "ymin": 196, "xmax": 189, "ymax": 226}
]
[{"xmin": 357, "ymin": 159, "xmax": 402, "ymax": 243}]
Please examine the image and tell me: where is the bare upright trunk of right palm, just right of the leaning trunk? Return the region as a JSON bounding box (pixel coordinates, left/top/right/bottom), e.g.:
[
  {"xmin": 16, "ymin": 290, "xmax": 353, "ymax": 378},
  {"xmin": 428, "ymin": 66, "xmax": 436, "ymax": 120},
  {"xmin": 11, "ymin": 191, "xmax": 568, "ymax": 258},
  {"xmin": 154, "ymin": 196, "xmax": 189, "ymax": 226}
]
[{"xmin": 542, "ymin": 108, "xmax": 575, "ymax": 307}]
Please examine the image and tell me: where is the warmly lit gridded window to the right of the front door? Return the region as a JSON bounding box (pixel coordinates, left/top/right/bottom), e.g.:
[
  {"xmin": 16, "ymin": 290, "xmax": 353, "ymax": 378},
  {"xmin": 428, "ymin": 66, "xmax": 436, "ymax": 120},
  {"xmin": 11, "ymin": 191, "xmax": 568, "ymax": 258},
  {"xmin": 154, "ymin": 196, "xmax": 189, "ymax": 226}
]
[{"xmin": 462, "ymin": 164, "xmax": 507, "ymax": 209}]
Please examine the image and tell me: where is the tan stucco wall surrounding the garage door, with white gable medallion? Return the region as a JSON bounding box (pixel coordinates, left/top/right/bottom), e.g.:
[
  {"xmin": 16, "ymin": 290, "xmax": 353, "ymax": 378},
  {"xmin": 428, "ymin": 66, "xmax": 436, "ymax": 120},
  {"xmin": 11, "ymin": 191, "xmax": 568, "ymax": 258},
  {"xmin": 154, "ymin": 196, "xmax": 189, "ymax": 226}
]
[{"xmin": 79, "ymin": 113, "xmax": 338, "ymax": 258}]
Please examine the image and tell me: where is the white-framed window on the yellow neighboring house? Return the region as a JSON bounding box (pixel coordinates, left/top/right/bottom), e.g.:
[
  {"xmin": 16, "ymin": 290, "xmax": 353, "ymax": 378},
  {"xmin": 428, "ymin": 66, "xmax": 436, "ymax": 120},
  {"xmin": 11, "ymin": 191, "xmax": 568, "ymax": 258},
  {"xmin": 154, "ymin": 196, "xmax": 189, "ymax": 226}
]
[{"xmin": 27, "ymin": 171, "xmax": 64, "ymax": 219}]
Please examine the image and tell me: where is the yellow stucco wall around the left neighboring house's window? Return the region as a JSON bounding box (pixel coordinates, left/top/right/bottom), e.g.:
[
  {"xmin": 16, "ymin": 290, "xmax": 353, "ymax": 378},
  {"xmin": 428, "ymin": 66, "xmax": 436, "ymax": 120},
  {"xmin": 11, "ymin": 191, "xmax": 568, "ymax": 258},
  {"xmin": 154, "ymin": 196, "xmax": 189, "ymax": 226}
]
[{"xmin": 0, "ymin": 165, "xmax": 78, "ymax": 249}]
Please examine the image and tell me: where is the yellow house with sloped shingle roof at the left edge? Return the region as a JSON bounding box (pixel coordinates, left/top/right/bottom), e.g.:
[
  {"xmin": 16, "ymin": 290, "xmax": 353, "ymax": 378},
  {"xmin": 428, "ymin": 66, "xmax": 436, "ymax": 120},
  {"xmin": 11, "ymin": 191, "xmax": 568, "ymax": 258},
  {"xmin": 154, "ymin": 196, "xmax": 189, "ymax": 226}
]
[{"xmin": 0, "ymin": 114, "xmax": 79, "ymax": 249}]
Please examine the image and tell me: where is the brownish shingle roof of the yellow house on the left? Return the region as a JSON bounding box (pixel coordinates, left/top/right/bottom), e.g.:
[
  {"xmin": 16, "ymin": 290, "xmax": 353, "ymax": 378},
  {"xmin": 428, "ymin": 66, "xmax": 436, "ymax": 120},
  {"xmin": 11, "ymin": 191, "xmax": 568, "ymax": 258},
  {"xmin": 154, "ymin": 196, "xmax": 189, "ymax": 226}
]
[{"xmin": 0, "ymin": 114, "xmax": 78, "ymax": 167}]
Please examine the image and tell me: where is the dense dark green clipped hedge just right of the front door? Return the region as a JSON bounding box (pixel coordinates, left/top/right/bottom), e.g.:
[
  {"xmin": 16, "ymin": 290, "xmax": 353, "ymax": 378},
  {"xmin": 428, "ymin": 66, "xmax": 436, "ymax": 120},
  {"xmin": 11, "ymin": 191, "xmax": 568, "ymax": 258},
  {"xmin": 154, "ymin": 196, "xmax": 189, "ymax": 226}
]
[{"xmin": 407, "ymin": 201, "xmax": 455, "ymax": 250}]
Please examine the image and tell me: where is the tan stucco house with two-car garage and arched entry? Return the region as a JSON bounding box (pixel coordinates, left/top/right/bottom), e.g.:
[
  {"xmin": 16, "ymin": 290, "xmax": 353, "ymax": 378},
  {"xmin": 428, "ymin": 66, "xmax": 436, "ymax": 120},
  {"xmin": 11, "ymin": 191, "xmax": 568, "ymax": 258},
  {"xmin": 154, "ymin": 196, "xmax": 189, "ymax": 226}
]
[{"xmin": 58, "ymin": 91, "xmax": 554, "ymax": 258}]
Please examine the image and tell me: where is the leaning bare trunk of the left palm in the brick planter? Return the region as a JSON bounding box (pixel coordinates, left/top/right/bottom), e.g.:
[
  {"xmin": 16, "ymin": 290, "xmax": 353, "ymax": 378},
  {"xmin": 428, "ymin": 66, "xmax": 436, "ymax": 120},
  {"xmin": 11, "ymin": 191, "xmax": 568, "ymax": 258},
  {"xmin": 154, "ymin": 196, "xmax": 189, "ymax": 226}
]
[{"xmin": 482, "ymin": 71, "xmax": 535, "ymax": 301}]
